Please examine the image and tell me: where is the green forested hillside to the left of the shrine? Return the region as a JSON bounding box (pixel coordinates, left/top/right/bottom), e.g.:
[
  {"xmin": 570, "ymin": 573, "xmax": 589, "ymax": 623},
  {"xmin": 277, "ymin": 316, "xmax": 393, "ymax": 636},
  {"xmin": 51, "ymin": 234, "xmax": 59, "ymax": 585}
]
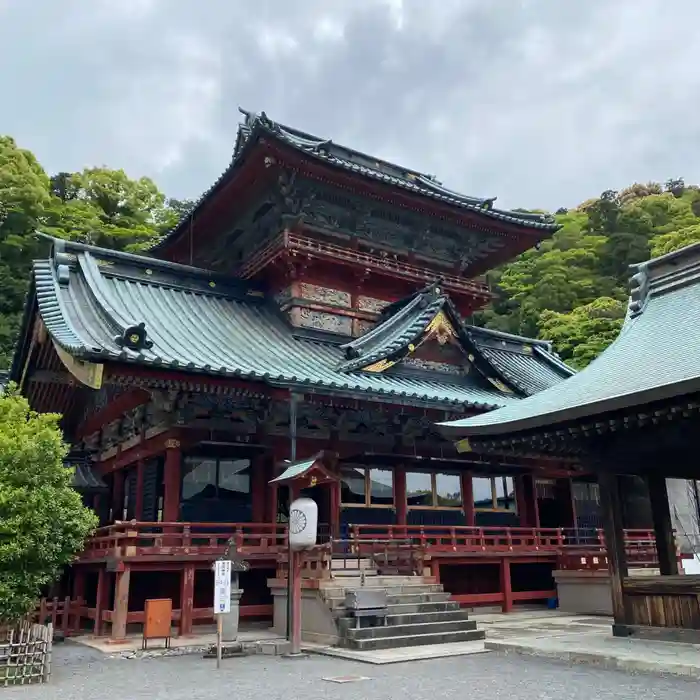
[{"xmin": 0, "ymin": 136, "xmax": 192, "ymax": 370}]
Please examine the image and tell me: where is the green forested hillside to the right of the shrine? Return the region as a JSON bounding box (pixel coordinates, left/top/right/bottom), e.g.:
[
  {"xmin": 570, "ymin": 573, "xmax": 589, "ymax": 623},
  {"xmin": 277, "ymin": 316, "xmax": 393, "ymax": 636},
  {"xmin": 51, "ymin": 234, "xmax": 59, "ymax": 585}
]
[{"xmin": 476, "ymin": 179, "xmax": 700, "ymax": 368}]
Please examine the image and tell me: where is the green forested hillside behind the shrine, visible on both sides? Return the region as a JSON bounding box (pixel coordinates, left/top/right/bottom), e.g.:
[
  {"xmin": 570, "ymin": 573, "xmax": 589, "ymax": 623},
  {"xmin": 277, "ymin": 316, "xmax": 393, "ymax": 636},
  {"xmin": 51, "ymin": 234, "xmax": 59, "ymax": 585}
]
[{"xmin": 0, "ymin": 136, "xmax": 700, "ymax": 370}]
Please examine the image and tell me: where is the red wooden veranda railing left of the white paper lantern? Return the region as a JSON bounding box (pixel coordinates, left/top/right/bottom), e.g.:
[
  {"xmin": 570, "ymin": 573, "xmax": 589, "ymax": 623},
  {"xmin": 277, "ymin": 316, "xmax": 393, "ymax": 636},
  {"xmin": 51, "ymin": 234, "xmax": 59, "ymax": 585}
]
[{"xmin": 80, "ymin": 521, "xmax": 287, "ymax": 561}]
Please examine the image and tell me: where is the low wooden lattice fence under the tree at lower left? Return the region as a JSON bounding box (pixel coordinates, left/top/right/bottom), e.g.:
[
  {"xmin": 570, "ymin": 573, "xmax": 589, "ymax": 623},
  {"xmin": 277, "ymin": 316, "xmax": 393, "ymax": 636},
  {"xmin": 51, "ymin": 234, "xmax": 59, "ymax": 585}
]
[{"xmin": 0, "ymin": 622, "xmax": 53, "ymax": 686}]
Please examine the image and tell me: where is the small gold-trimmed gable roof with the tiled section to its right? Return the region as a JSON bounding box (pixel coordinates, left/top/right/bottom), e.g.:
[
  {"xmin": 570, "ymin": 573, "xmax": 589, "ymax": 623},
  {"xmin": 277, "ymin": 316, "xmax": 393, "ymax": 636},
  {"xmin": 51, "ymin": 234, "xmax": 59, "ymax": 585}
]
[{"xmin": 340, "ymin": 282, "xmax": 574, "ymax": 396}]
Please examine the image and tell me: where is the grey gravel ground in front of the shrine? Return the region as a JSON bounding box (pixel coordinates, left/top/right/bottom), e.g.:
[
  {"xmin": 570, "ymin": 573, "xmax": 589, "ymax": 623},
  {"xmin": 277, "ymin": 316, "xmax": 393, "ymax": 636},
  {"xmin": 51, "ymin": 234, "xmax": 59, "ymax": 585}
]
[{"xmin": 10, "ymin": 643, "xmax": 700, "ymax": 700}]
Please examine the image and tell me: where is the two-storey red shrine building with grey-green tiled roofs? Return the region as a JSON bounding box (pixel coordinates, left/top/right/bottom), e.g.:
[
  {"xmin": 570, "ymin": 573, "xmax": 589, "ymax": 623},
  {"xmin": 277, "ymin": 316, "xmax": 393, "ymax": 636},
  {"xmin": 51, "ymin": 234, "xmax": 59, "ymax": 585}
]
[{"xmin": 11, "ymin": 112, "xmax": 649, "ymax": 639}]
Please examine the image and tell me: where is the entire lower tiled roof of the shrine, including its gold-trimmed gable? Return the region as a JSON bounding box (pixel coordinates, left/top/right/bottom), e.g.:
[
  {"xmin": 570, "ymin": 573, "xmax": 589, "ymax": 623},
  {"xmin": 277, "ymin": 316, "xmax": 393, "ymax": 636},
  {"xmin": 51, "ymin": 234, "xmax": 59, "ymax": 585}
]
[{"xmin": 13, "ymin": 241, "xmax": 571, "ymax": 410}]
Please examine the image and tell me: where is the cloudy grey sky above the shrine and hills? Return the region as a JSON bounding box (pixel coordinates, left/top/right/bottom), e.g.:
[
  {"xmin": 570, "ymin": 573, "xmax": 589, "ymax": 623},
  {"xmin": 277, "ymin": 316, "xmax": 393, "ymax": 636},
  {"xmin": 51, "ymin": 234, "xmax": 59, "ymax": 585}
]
[{"xmin": 0, "ymin": 0, "xmax": 700, "ymax": 209}]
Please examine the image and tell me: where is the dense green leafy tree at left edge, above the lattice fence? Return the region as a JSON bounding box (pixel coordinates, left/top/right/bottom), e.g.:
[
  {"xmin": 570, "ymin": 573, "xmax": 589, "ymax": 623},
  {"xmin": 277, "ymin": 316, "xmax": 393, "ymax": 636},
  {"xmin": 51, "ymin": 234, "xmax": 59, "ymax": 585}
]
[{"xmin": 0, "ymin": 388, "xmax": 97, "ymax": 623}]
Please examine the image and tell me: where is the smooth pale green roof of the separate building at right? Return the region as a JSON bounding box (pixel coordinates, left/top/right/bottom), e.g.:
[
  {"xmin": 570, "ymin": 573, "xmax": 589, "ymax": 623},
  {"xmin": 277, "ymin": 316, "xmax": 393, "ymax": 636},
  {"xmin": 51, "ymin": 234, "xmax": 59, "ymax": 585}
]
[{"xmin": 442, "ymin": 244, "xmax": 700, "ymax": 435}]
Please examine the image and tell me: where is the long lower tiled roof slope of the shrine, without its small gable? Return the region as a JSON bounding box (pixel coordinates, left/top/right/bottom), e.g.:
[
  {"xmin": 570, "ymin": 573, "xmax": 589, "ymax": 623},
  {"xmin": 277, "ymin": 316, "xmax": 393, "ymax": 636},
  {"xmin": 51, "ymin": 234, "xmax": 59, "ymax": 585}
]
[{"xmin": 27, "ymin": 241, "xmax": 517, "ymax": 410}]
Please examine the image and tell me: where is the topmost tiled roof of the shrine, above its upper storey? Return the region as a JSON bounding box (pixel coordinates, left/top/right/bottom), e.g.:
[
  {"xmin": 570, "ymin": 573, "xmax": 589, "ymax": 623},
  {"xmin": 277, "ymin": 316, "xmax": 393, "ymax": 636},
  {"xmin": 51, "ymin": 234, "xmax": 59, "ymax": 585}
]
[{"xmin": 154, "ymin": 109, "xmax": 560, "ymax": 249}]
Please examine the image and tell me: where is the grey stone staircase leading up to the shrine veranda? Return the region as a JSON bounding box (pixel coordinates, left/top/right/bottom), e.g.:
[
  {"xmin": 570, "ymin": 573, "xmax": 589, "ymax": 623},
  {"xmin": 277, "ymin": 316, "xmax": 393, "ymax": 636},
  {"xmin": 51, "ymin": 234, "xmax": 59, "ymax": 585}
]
[{"xmin": 320, "ymin": 560, "xmax": 485, "ymax": 650}]
